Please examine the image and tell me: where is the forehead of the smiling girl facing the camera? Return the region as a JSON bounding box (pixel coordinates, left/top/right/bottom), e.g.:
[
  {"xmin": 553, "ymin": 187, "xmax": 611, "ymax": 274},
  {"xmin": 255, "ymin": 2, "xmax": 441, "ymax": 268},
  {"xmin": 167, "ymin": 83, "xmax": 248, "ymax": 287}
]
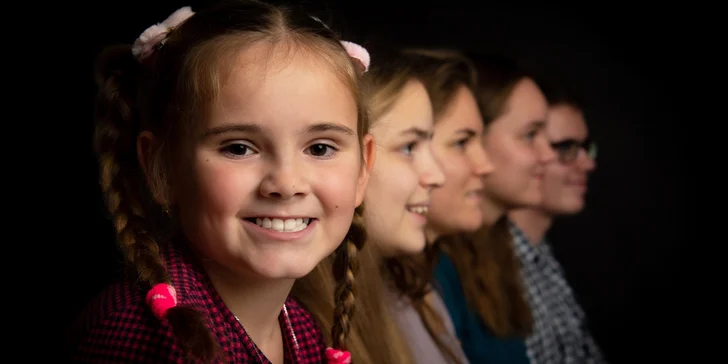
[{"xmin": 211, "ymin": 41, "xmax": 357, "ymax": 130}]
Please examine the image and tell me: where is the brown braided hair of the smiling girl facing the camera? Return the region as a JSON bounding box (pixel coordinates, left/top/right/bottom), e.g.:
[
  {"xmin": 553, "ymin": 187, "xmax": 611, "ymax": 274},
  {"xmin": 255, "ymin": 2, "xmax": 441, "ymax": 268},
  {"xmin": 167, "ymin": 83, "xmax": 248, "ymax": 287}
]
[{"xmin": 94, "ymin": 0, "xmax": 368, "ymax": 361}]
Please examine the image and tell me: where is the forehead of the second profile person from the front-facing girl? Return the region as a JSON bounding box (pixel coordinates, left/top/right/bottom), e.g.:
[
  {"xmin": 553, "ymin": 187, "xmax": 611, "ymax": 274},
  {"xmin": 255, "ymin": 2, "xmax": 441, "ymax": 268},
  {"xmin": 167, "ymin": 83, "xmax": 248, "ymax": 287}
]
[{"xmin": 435, "ymin": 86, "xmax": 483, "ymax": 134}]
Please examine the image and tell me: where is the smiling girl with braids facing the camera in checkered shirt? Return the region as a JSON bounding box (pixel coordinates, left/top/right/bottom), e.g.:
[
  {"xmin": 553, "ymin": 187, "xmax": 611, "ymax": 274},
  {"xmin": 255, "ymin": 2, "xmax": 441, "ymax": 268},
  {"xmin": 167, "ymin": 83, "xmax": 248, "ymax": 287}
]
[{"xmin": 68, "ymin": 0, "xmax": 375, "ymax": 363}]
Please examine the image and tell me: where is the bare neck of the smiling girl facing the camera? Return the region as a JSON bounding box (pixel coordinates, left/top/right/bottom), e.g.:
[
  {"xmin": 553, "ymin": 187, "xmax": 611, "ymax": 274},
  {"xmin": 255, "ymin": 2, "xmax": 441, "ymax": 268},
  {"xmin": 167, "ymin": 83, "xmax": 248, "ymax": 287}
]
[{"xmin": 203, "ymin": 260, "xmax": 294, "ymax": 347}]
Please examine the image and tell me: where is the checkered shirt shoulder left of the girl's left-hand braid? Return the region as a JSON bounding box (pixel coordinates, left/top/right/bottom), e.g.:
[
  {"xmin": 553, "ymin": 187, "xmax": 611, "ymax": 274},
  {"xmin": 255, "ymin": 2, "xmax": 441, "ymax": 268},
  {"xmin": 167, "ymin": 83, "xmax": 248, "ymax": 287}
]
[{"xmin": 66, "ymin": 281, "xmax": 181, "ymax": 363}]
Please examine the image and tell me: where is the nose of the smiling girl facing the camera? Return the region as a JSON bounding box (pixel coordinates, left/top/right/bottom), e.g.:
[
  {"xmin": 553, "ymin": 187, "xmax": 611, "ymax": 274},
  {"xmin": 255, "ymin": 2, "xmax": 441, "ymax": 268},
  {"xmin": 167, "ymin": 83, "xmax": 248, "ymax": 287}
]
[{"xmin": 259, "ymin": 160, "xmax": 310, "ymax": 199}]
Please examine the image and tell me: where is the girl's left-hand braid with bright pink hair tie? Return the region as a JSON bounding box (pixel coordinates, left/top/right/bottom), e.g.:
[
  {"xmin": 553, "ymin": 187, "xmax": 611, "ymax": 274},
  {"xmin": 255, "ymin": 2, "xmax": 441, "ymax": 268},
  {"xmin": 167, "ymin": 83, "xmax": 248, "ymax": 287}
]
[{"xmin": 94, "ymin": 46, "xmax": 218, "ymax": 361}]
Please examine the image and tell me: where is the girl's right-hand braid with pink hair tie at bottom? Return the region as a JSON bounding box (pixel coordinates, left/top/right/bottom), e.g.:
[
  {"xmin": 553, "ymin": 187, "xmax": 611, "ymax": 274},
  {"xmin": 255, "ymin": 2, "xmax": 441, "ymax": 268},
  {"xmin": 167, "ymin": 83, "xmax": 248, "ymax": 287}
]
[{"xmin": 326, "ymin": 206, "xmax": 366, "ymax": 363}]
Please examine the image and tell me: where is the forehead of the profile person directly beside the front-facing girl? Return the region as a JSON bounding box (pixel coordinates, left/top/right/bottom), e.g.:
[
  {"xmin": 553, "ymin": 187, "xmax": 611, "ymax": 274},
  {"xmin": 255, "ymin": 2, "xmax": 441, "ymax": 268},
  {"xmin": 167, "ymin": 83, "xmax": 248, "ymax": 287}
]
[{"xmin": 372, "ymin": 80, "xmax": 433, "ymax": 140}]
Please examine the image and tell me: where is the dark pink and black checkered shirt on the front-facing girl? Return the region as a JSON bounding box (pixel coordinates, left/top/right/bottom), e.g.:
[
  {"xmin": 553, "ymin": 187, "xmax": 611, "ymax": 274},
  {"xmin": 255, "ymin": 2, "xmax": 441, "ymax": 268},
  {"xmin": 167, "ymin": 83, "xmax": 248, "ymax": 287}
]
[{"xmin": 67, "ymin": 242, "xmax": 325, "ymax": 364}]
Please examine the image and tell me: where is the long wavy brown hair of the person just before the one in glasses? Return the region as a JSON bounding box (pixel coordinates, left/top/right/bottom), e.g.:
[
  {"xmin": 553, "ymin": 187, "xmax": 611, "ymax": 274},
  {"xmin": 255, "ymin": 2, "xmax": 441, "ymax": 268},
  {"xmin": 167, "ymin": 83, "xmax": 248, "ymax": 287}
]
[{"xmin": 438, "ymin": 54, "xmax": 533, "ymax": 338}]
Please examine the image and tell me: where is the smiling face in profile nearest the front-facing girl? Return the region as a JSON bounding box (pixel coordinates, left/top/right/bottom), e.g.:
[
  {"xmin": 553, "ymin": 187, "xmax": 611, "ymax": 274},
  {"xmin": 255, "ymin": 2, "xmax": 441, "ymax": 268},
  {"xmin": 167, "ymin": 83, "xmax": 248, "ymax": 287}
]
[{"xmin": 364, "ymin": 81, "xmax": 444, "ymax": 256}]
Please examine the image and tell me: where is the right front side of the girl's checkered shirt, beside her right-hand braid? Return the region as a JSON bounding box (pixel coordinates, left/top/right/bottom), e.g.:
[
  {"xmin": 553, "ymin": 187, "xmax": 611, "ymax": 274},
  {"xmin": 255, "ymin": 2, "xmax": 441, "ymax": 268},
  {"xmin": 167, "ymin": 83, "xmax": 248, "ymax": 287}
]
[{"xmin": 286, "ymin": 297, "xmax": 326, "ymax": 363}]
